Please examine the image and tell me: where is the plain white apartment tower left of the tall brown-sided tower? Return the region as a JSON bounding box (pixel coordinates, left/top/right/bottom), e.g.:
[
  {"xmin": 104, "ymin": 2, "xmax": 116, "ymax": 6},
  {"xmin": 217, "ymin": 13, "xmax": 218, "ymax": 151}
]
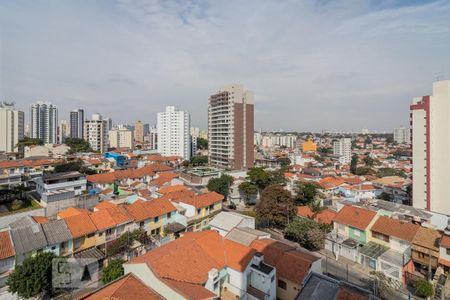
[{"xmin": 156, "ymin": 106, "xmax": 191, "ymax": 160}]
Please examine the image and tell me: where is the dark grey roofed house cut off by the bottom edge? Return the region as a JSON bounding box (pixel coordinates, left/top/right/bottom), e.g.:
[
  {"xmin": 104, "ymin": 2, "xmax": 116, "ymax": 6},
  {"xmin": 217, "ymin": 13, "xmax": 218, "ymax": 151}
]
[{"xmin": 295, "ymin": 272, "xmax": 379, "ymax": 300}]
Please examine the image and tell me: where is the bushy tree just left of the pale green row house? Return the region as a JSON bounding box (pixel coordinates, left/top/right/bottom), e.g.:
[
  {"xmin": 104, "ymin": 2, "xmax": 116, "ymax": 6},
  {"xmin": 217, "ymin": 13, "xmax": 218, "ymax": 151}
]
[{"xmin": 285, "ymin": 217, "xmax": 325, "ymax": 250}]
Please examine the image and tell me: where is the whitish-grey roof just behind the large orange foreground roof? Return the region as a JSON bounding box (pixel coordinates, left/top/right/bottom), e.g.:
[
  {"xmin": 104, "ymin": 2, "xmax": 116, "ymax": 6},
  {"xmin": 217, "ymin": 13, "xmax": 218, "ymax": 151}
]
[{"xmin": 209, "ymin": 211, "xmax": 255, "ymax": 236}]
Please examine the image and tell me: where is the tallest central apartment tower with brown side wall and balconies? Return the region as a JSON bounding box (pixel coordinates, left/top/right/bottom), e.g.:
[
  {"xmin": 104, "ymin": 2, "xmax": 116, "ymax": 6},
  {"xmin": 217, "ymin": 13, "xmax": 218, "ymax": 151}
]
[{"xmin": 208, "ymin": 84, "xmax": 254, "ymax": 170}]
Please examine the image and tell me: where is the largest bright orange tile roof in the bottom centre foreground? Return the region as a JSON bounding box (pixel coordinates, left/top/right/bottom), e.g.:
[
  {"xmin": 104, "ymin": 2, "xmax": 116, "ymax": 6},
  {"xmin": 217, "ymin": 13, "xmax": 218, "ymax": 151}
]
[{"xmin": 130, "ymin": 231, "xmax": 256, "ymax": 284}]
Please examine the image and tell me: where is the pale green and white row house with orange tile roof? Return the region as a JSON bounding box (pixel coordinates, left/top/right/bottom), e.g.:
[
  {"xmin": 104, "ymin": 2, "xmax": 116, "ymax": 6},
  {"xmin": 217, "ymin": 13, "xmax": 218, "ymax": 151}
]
[{"xmin": 325, "ymin": 205, "xmax": 378, "ymax": 261}]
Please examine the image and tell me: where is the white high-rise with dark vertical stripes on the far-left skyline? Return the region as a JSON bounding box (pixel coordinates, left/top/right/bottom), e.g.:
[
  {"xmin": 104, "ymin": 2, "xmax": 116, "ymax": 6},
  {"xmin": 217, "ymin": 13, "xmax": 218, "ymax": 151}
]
[{"xmin": 30, "ymin": 101, "xmax": 58, "ymax": 144}]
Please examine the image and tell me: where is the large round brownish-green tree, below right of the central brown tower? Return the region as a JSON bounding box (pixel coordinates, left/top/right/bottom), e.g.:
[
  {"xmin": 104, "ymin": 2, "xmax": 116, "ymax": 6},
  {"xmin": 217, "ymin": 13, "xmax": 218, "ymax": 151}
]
[{"xmin": 256, "ymin": 185, "xmax": 296, "ymax": 228}]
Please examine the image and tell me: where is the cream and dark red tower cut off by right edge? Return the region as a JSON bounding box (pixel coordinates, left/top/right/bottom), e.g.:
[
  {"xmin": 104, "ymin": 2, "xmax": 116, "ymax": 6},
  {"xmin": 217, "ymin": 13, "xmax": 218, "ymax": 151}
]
[{"xmin": 410, "ymin": 80, "xmax": 450, "ymax": 215}]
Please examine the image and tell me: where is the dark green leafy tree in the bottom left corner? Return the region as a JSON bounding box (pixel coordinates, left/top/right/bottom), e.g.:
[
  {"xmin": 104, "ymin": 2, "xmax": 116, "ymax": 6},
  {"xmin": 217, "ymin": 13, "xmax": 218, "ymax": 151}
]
[{"xmin": 6, "ymin": 252, "xmax": 55, "ymax": 298}]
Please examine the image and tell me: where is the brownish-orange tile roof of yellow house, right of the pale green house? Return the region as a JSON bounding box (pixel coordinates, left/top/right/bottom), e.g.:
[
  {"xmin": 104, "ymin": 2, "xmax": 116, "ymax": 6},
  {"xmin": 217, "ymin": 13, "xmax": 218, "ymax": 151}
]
[{"xmin": 371, "ymin": 216, "xmax": 420, "ymax": 242}]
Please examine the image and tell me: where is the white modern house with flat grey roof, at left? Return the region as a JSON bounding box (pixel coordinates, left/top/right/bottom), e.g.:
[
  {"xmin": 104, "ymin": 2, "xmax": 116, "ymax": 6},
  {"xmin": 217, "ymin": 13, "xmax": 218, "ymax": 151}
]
[{"xmin": 35, "ymin": 172, "xmax": 87, "ymax": 206}]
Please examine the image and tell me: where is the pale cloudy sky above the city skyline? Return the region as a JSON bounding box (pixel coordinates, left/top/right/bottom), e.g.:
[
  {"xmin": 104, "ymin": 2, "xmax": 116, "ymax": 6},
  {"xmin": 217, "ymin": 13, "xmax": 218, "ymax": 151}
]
[{"xmin": 0, "ymin": 0, "xmax": 450, "ymax": 132}]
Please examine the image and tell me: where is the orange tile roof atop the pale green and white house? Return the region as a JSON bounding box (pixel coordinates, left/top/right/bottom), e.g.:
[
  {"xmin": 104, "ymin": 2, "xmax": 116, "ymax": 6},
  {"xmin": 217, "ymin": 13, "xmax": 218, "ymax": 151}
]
[{"xmin": 334, "ymin": 205, "xmax": 377, "ymax": 230}]
